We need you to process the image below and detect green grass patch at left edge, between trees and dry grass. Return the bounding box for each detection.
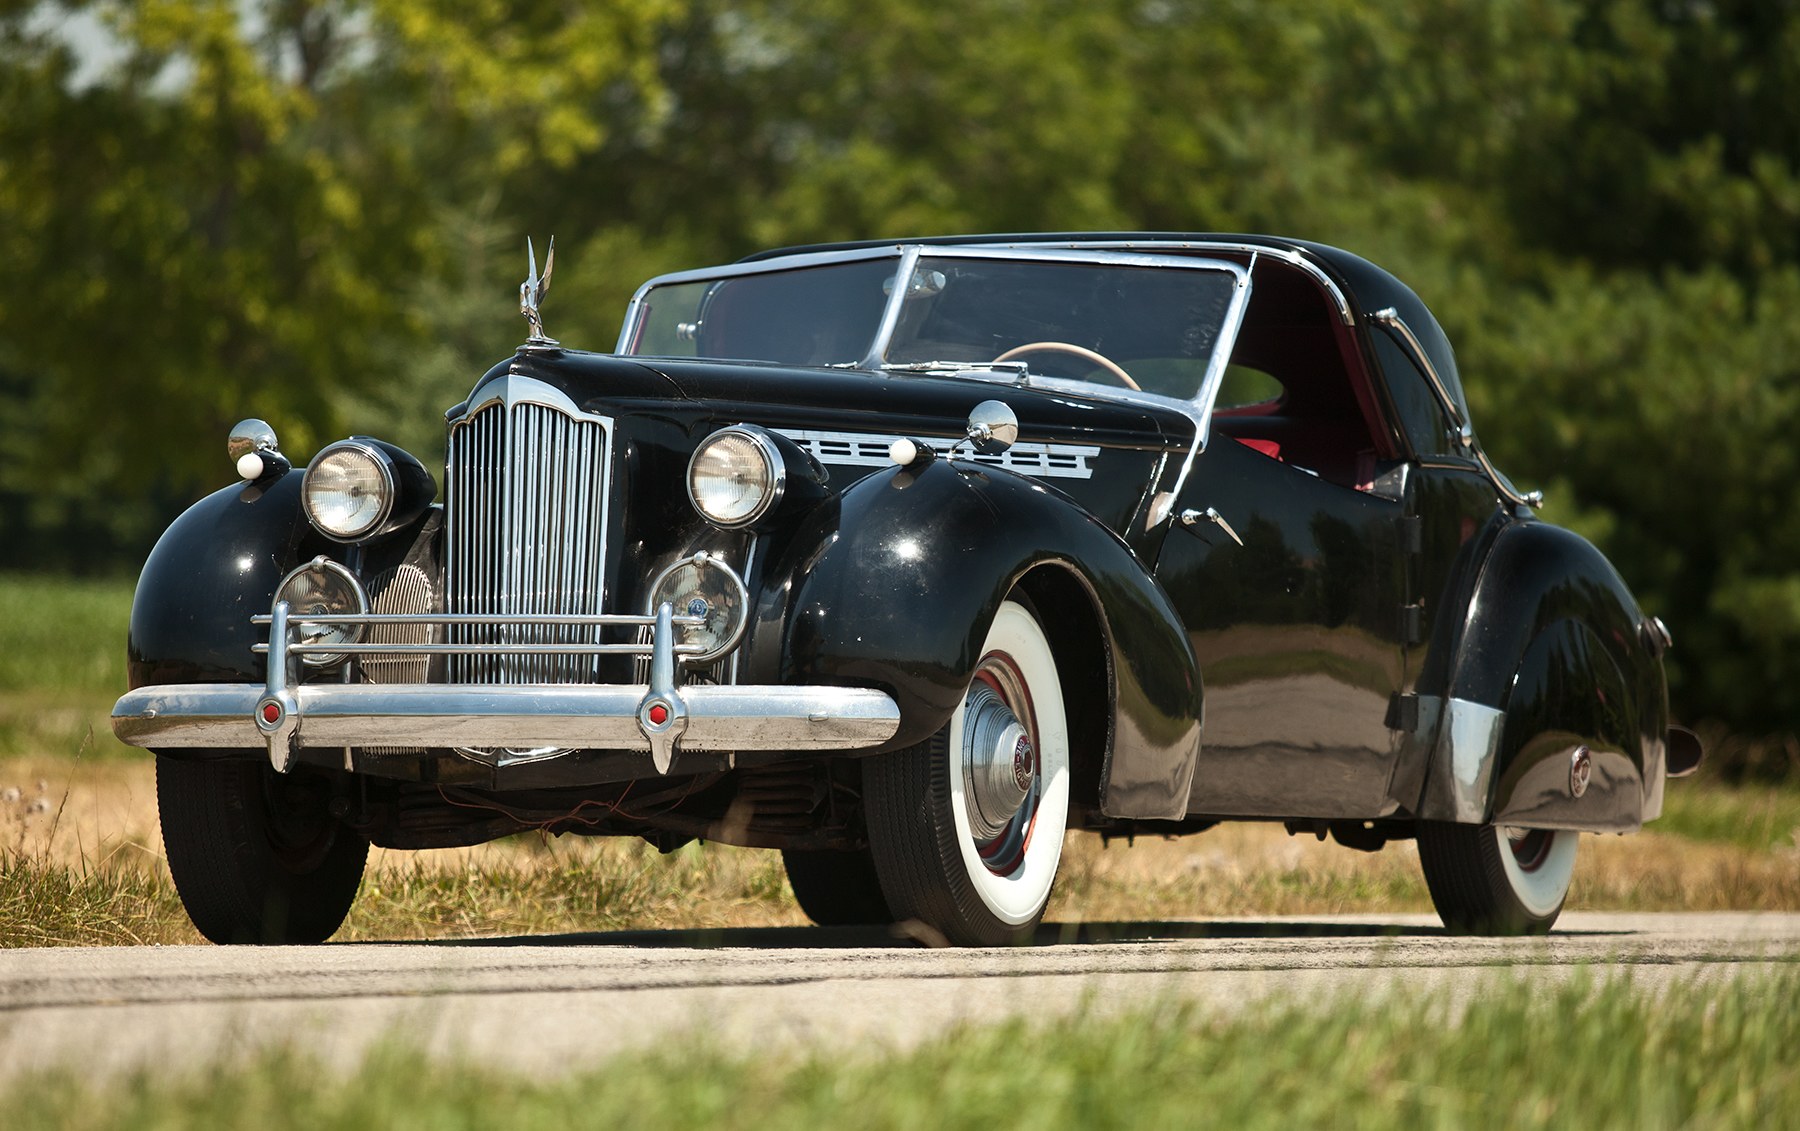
[0,575,133,758]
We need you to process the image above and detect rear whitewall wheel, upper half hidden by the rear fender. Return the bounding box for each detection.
[1418,821,1580,935]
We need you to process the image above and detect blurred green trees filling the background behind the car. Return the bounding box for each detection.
[0,0,1800,765]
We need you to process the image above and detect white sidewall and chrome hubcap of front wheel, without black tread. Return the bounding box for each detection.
[949,602,1069,924]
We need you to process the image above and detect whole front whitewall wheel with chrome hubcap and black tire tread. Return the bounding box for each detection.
[862,602,1069,946]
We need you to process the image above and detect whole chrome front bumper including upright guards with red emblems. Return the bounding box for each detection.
[113,603,900,773]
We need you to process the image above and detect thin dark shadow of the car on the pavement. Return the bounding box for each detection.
[412,920,1629,951]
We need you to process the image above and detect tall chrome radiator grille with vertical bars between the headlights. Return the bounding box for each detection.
[445,376,612,684]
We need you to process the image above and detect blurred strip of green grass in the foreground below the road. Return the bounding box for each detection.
[0,967,1800,1131]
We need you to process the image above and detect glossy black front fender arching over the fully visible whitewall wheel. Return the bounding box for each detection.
[749,459,1201,818]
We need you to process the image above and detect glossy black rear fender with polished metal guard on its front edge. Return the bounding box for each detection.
[1420,520,1669,832]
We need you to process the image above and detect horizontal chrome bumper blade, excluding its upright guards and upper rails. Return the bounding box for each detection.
[113,683,900,756]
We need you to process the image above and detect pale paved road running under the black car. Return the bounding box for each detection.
[0,913,1800,1073]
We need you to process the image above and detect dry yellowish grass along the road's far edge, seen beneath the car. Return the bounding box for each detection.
[0,758,1800,946]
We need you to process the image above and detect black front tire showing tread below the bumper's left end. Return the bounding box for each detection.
[157,758,369,944]
